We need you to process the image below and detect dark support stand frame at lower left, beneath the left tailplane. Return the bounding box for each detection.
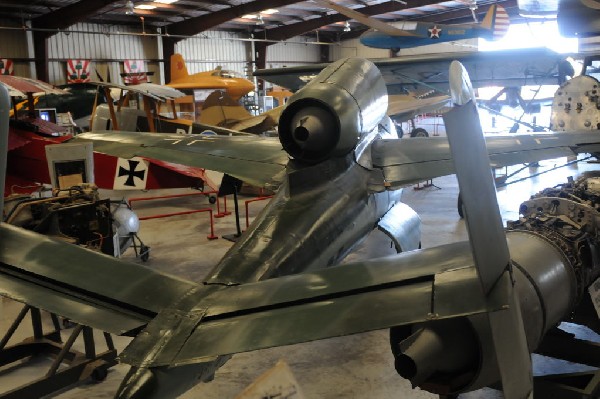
[0,305,117,399]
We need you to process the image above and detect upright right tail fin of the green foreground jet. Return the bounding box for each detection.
[444,61,533,399]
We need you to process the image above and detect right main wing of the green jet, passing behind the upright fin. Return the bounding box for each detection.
[372,131,600,188]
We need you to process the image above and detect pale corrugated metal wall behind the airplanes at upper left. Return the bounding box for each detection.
[0,21,320,84]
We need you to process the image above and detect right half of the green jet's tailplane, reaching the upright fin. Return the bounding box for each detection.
[122,242,505,367]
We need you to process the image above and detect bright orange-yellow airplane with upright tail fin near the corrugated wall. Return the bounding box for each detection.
[167,54,254,101]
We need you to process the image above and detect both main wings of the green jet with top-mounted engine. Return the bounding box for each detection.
[74,131,600,189]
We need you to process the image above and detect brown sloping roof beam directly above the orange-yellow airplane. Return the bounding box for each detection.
[167,0,308,36]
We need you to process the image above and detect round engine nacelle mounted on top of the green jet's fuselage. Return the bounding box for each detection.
[279,58,388,164]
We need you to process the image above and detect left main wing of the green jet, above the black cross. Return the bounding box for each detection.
[72,132,288,186]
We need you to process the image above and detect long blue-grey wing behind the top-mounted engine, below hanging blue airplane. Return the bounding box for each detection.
[254,48,572,94]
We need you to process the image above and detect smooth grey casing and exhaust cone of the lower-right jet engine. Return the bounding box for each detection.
[390,231,577,395]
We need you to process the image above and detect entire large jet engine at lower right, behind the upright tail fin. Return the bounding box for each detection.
[390,173,600,395]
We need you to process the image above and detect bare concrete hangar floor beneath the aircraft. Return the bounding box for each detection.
[0,158,593,399]
